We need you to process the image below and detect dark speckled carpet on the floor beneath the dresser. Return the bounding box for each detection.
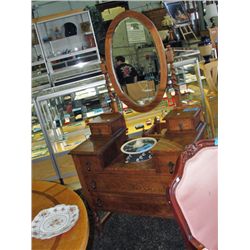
[76,190,185,250]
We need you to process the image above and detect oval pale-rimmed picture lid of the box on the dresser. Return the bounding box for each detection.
[121,137,157,155]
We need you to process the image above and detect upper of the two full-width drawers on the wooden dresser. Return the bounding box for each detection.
[85,174,172,195]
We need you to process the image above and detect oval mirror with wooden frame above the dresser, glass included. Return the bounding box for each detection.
[105,10,167,112]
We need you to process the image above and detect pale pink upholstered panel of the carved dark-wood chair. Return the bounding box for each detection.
[176,146,218,250]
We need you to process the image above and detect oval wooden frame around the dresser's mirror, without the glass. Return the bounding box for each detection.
[105,10,168,112]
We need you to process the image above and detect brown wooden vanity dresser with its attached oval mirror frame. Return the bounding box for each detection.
[70,11,206,227]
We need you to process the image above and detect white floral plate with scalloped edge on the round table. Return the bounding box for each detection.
[31,204,79,239]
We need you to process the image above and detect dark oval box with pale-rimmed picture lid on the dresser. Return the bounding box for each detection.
[121,137,157,163]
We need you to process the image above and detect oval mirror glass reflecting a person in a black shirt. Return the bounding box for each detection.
[112,18,160,105]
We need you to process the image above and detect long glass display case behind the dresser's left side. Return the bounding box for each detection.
[32,75,111,184]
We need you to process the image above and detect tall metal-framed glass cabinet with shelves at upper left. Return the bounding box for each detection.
[32,10,101,91]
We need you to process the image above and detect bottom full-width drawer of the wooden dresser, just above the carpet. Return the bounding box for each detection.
[93,193,174,218]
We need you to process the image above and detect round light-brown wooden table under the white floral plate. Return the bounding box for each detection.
[32,181,89,250]
